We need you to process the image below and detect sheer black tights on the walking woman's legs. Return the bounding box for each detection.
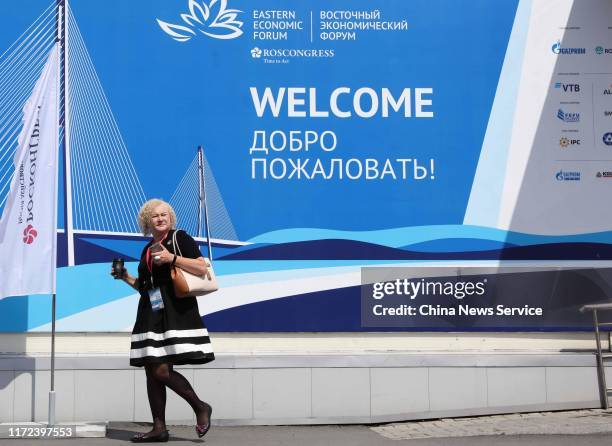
[145,364,209,431]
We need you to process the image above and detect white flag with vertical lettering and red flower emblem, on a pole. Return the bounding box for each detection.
[0,44,59,299]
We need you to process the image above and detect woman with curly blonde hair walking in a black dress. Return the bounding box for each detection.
[113,199,215,443]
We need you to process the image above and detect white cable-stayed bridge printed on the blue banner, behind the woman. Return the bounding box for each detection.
[0,2,246,266]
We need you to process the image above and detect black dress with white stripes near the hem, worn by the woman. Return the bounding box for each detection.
[130,230,215,367]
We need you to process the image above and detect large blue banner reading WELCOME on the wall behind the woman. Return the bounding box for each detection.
[0,0,612,331]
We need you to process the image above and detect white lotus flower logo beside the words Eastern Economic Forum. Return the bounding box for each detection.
[156,0,243,42]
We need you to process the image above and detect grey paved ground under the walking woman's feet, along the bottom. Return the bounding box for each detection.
[0,410,612,446]
